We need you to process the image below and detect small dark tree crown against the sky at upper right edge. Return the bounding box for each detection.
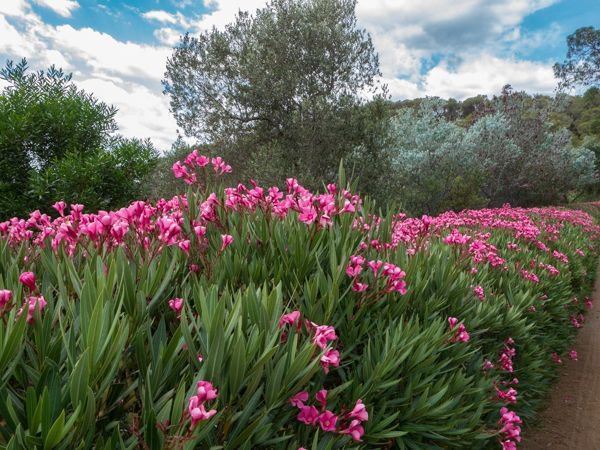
[554,27,600,89]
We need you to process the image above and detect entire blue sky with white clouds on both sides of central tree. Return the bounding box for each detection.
[0,0,600,149]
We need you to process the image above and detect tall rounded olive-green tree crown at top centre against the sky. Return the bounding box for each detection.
[164,0,379,186]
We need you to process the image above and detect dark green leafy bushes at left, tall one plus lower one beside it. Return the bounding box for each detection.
[0,60,157,218]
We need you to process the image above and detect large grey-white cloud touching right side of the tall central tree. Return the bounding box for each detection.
[357,0,558,89]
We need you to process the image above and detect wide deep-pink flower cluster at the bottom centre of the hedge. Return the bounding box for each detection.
[289,389,369,442]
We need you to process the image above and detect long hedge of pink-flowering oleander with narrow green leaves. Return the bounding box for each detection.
[0,152,599,449]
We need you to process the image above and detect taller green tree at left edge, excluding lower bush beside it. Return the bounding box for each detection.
[0,59,117,217]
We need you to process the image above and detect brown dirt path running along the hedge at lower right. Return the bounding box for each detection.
[519,267,600,450]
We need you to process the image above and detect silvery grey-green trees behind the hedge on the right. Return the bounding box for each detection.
[389,90,598,214]
